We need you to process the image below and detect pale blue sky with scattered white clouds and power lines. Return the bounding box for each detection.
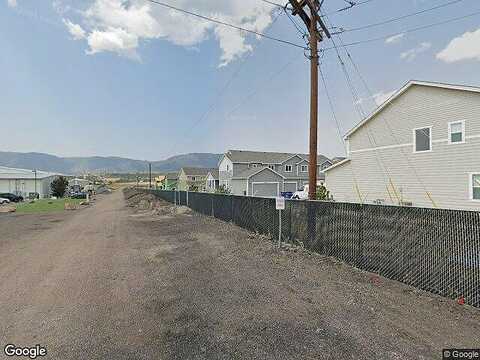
[0,0,480,160]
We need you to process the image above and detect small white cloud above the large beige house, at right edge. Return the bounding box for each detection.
[437,29,480,63]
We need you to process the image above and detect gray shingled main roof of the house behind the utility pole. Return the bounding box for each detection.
[225,150,329,164]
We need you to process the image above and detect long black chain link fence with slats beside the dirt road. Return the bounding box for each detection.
[145,190,480,307]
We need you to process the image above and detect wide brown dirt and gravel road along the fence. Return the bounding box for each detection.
[0,192,480,360]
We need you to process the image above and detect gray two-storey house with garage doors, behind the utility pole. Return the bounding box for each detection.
[219,150,333,197]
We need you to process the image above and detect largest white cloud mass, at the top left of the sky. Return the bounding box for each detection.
[55,0,274,66]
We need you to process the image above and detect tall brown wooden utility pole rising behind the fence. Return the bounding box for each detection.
[289,0,330,200]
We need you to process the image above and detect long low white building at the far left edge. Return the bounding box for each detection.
[0,166,59,198]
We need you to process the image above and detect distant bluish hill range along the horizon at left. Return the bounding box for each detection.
[0,151,221,174]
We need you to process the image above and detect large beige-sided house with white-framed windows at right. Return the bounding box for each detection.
[326,81,480,210]
